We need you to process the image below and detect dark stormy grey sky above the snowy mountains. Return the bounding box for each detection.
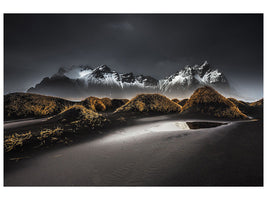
[4,14,263,99]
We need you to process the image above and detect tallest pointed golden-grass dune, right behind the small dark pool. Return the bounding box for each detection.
[182,86,248,119]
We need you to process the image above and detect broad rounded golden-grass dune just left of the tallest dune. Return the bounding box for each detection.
[115,94,182,113]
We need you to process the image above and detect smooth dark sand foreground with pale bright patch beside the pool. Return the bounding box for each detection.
[4,116,263,186]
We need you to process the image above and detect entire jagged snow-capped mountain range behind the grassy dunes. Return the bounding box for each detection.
[28,62,230,98]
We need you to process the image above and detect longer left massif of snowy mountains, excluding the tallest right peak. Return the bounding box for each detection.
[27,65,158,98]
